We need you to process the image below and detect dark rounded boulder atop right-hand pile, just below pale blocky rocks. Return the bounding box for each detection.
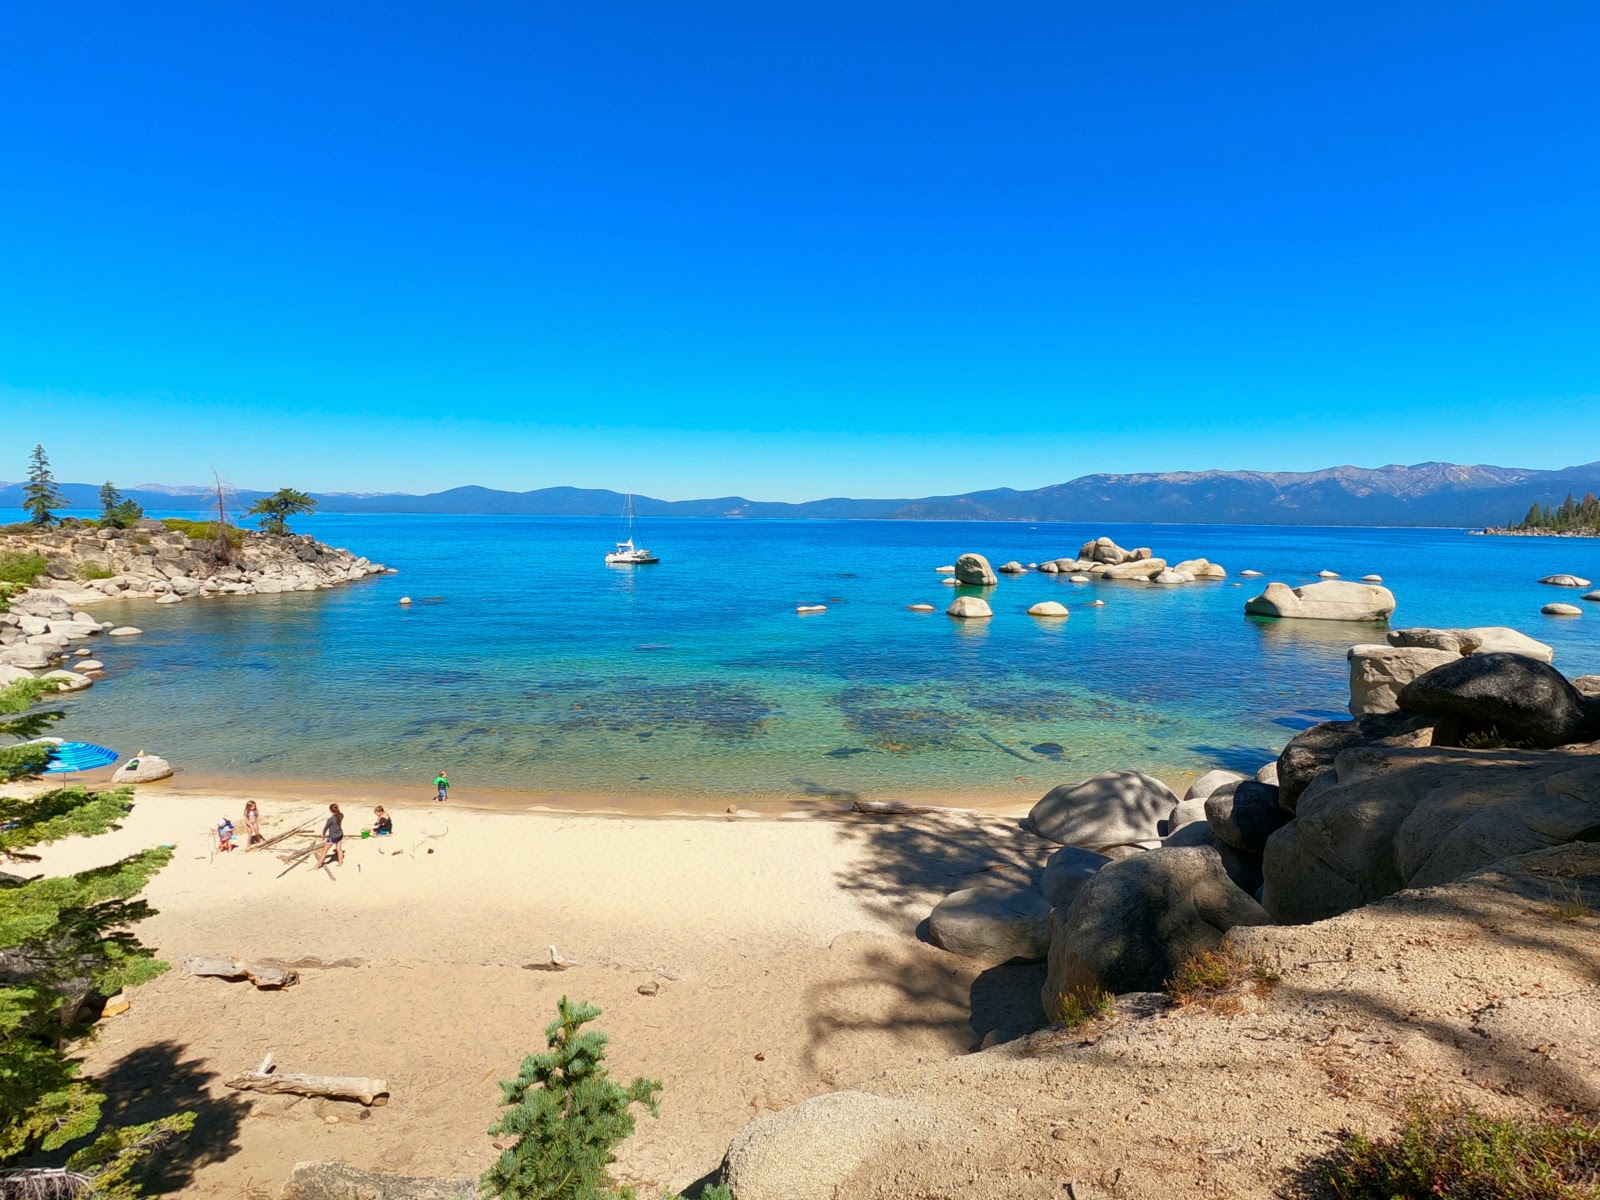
[1398,654,1587,747]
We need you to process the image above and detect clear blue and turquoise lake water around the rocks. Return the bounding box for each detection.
[21,515,1600,800]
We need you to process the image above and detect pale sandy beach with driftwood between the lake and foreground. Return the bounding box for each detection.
[42,786,1038,1197]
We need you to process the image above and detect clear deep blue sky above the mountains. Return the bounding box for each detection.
[0,0,1600,499]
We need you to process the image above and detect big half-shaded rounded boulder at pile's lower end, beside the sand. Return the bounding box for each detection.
[1043,846,1269,1013]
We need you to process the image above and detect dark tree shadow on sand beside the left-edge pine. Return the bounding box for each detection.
[94,1042,250,1195]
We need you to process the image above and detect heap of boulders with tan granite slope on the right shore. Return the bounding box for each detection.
[722,643,1600,1200]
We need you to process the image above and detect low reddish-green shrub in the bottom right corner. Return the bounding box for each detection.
[1304,1099,1600,1200]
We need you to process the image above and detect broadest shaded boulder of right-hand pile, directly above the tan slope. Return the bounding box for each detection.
[1262,746,1600,923]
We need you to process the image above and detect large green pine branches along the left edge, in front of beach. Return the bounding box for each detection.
[0,680,194,1200]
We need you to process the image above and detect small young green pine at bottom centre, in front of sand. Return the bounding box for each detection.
[483,995,661,1200]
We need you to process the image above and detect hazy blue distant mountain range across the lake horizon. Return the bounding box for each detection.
[0,462,1600,526]
